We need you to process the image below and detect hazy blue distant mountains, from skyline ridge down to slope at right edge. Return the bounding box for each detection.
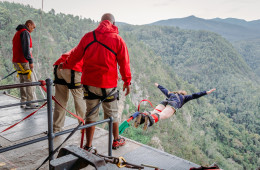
[151,16,260,77]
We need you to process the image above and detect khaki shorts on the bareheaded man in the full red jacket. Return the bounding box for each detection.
[83,86,118,122]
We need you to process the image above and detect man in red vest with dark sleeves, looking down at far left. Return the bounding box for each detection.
[12,20,39,109]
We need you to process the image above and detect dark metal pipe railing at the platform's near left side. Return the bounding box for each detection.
[0,79,113,169]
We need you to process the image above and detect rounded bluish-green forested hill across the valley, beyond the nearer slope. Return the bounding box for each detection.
[120,26,260,131]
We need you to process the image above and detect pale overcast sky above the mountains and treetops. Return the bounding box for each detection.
[0,0,260,25]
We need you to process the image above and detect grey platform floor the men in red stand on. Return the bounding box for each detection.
[0,94,199,170]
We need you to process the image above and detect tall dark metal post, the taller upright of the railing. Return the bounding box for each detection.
[46,79,54,168]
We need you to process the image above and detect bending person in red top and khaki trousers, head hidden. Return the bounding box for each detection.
[53,49,86,133]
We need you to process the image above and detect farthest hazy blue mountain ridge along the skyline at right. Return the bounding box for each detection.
[149,16,260,41]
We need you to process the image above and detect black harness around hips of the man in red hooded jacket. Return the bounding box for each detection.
[83,85,119,102]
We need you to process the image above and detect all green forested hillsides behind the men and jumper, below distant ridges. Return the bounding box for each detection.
[0,2,260,169]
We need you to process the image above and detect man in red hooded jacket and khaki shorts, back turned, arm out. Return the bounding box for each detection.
[63,13,131,150]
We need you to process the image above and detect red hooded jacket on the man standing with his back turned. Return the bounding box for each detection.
[64,20,131,88]
